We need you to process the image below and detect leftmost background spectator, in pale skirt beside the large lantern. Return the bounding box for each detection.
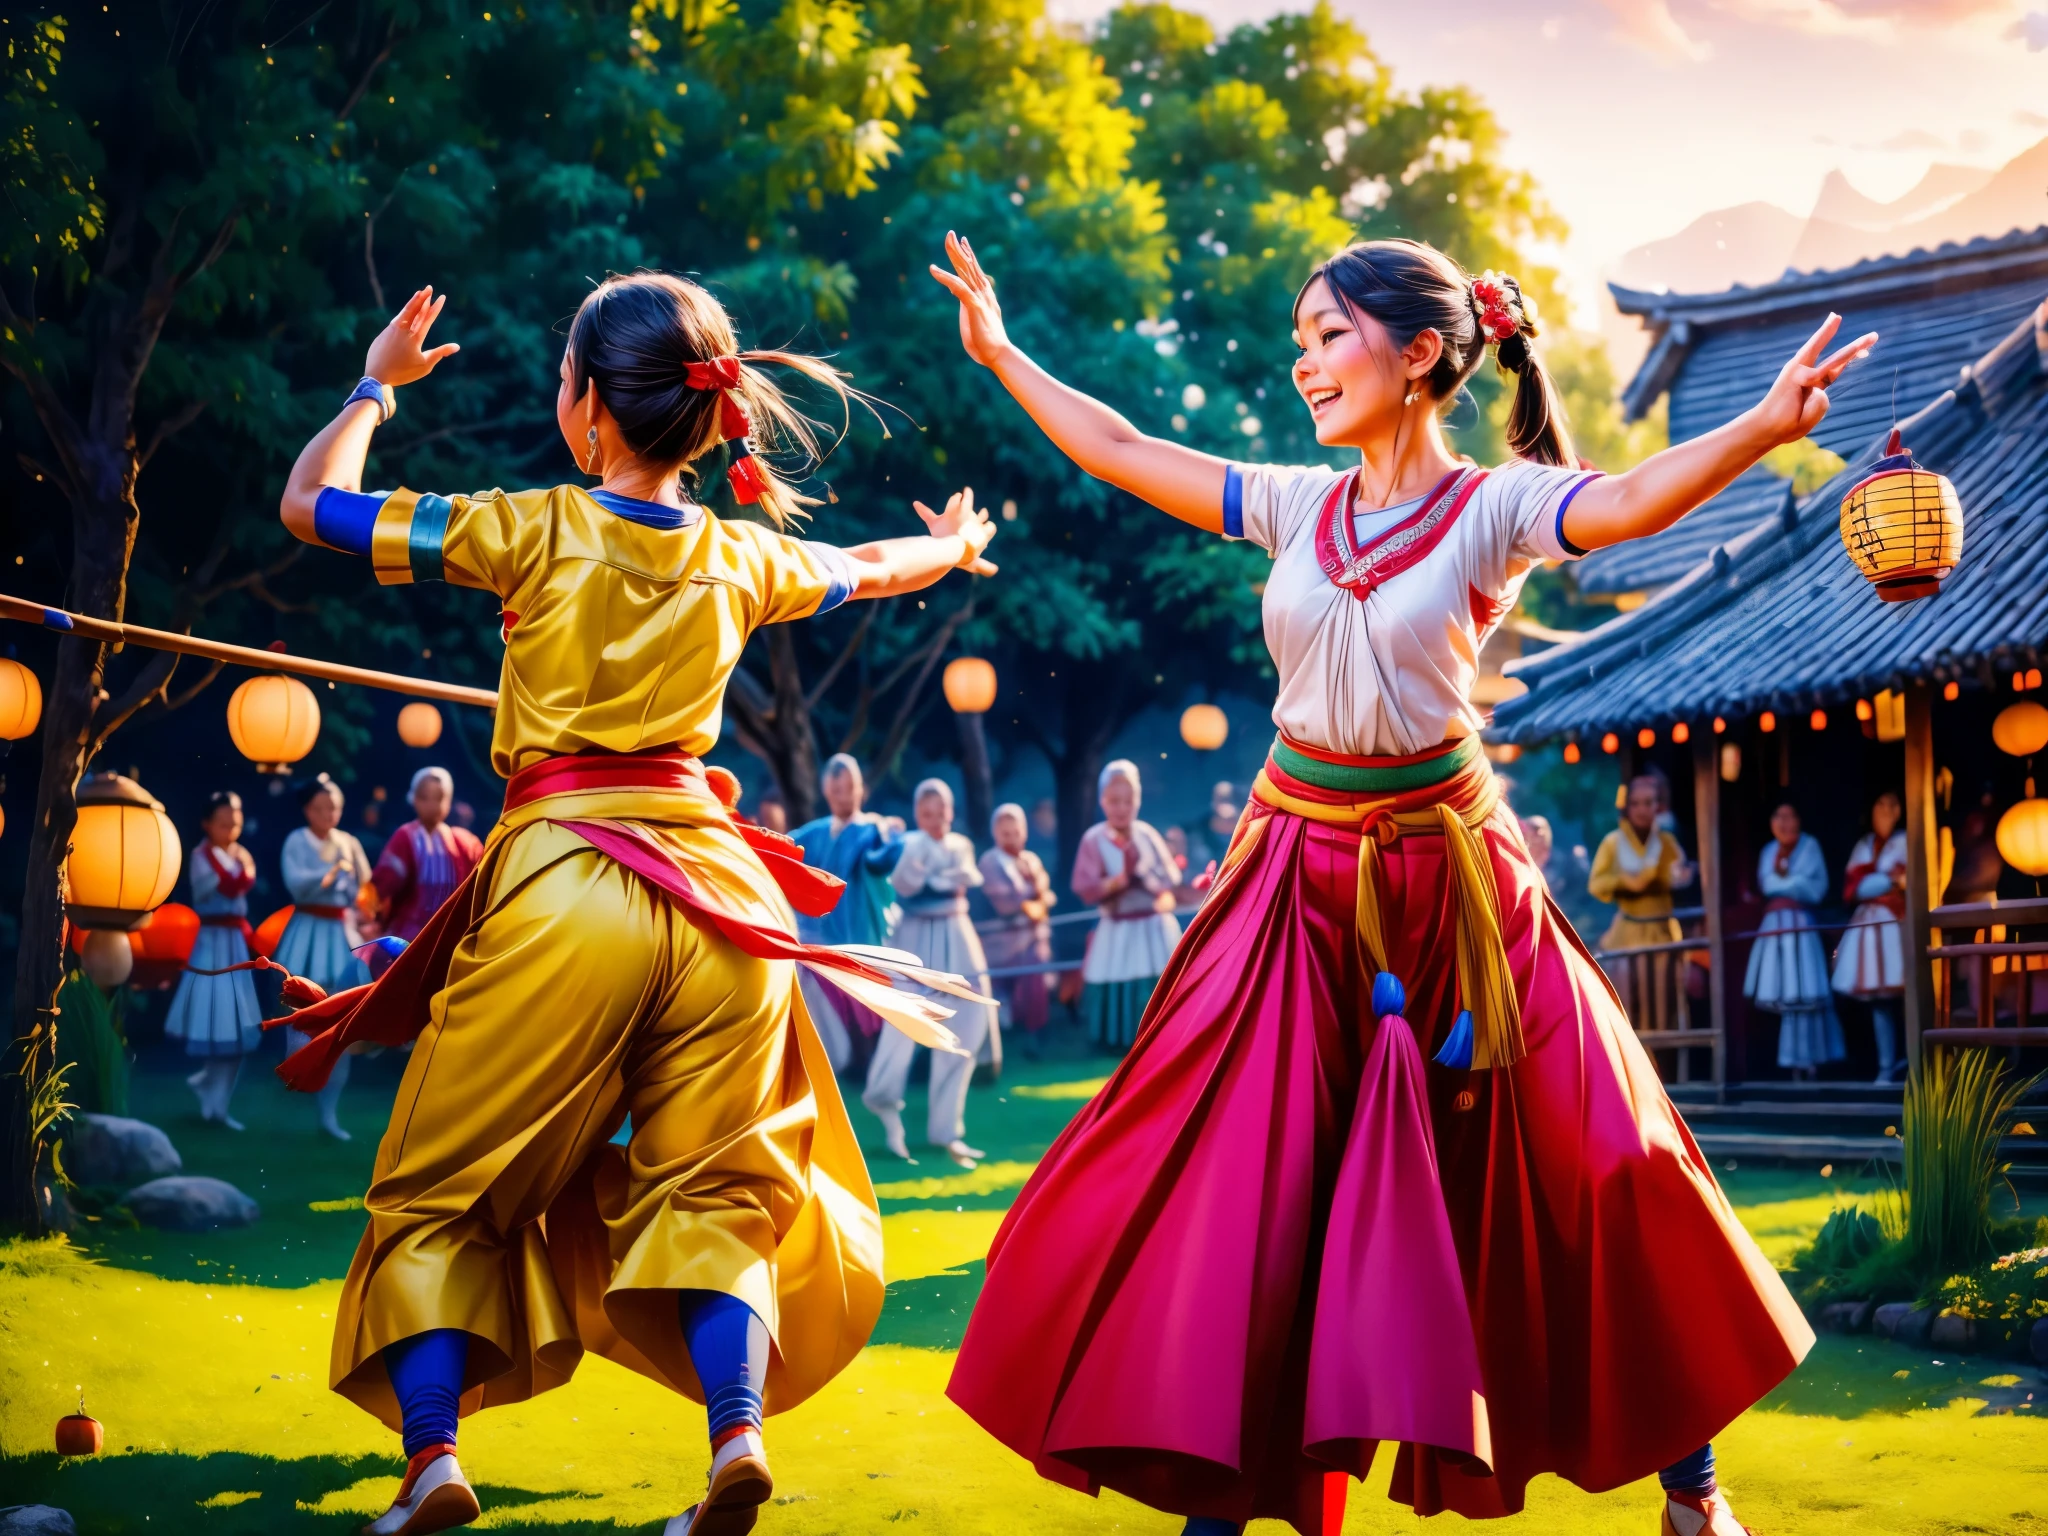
[164,791,262,1130]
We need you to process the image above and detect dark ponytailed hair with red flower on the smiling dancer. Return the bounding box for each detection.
[1294,240,1579,465]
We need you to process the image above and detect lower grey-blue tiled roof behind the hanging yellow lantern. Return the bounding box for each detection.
[1489,305,2048,743]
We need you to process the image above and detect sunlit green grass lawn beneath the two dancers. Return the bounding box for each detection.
[0,1040,2048,1536]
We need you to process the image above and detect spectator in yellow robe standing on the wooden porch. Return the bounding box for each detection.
[1585,774,1694,1030]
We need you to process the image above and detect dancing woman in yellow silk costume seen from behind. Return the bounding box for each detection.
[281,274,993,1536]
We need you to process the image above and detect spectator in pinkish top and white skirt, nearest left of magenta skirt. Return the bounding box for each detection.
[1073,758,1180,1055]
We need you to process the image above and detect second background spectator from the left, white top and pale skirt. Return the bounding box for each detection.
[270,774,371,1141]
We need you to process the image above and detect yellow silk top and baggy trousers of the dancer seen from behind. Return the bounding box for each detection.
[330,487,883,1427]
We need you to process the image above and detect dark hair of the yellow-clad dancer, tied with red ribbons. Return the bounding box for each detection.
[569,272,850,524]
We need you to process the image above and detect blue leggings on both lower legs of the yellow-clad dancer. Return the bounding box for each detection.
[383,1290,768,1456]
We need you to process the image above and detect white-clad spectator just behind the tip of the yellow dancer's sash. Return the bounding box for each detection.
[860,778,1001,1167]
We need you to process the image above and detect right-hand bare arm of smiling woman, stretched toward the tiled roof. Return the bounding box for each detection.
[1565,315,1878,549]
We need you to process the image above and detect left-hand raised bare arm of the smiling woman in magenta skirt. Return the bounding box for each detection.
[932,229,1227,532]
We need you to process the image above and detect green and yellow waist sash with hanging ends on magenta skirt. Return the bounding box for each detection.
[1219,737,1526,1069]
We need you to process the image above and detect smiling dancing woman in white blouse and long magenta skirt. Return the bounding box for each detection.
[932,236,1876,1536]
